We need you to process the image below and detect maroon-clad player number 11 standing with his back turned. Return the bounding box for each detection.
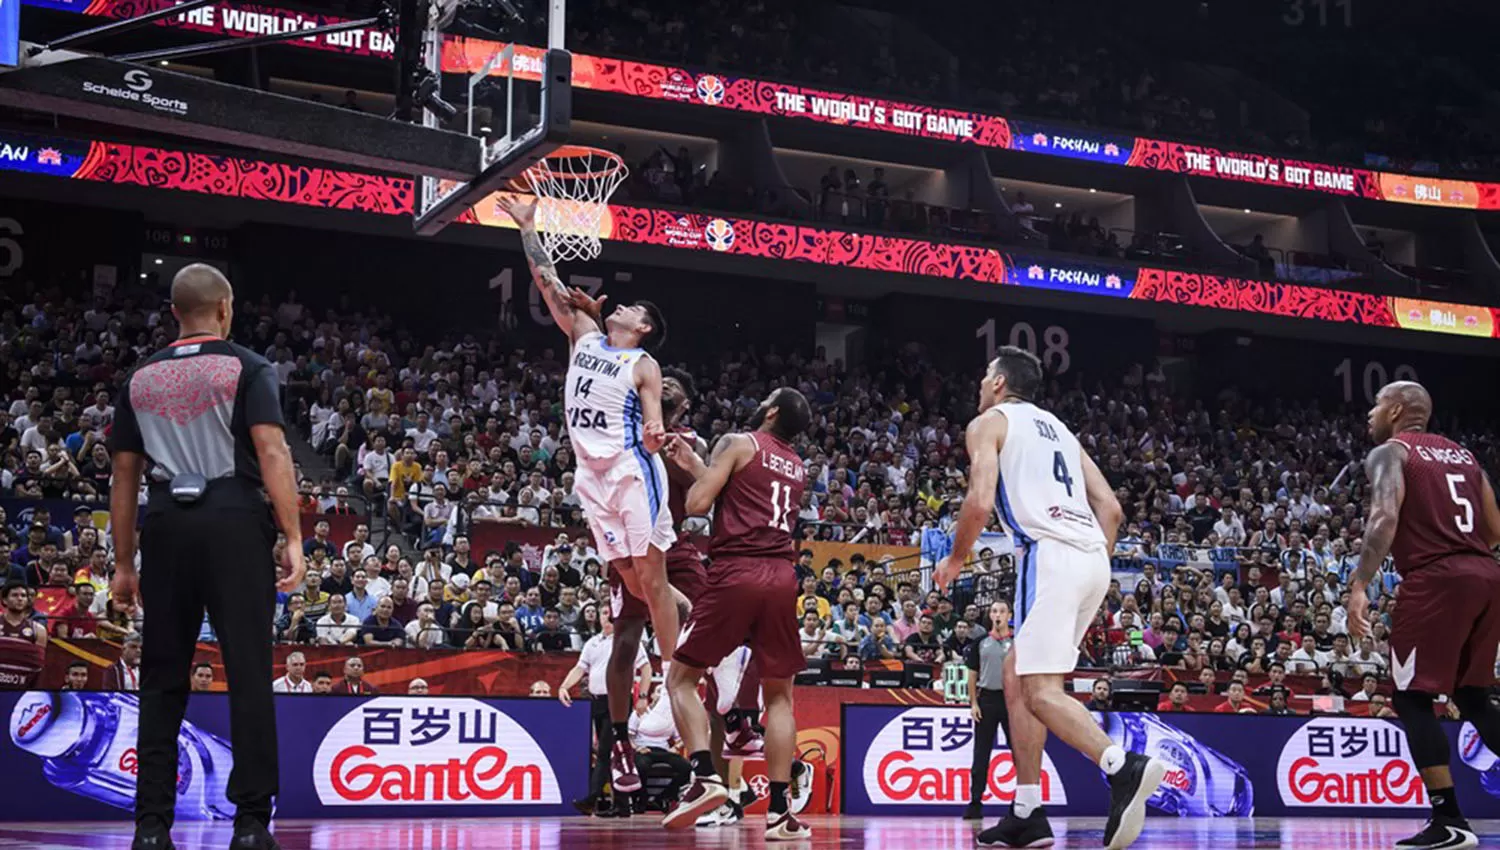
[662,387,812,841]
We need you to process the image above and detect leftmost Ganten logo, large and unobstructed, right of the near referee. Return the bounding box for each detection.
[312,697,561,807]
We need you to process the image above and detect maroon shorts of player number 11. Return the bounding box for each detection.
[674,555,807,679]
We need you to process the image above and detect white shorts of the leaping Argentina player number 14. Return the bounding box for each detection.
[573,450,677,561]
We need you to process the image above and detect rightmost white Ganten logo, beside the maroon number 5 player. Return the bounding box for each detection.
[1277,718,1427,808]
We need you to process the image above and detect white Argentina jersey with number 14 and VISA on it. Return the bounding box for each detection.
[563,331,650,466]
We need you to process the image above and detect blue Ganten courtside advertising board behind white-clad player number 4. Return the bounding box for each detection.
[840,705,1500,819]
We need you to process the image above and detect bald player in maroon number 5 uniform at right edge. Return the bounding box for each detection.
[1349,381,1500,850]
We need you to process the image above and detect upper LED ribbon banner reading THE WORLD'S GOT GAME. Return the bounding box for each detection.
[24,0,1500,210]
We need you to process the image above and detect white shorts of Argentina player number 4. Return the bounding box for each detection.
[1011,540,1110,676]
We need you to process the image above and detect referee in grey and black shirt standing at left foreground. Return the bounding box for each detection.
[110,264,305,850]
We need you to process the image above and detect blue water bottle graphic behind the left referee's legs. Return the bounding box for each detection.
[11,691,236,820]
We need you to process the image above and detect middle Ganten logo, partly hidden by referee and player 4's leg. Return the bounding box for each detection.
[861,706,1068,805]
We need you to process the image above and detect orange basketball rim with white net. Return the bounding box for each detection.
[525,145,630,262]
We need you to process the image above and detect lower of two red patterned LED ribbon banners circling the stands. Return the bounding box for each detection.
[0,133,1500,337]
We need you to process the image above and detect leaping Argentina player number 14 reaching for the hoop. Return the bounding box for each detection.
[498,196,680,677]
